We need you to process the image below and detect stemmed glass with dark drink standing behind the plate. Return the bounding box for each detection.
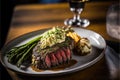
[64,0,90,27]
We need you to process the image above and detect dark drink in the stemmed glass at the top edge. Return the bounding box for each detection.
[69,0,85,8]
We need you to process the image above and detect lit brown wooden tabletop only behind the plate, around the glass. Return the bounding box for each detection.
[6,2,118,43]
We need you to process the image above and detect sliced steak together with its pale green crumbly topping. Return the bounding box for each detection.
[32,29,74,69]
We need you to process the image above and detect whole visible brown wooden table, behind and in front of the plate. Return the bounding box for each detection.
[6,2,118,80]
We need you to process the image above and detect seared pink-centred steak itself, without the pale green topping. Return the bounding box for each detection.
[32,38,74,69]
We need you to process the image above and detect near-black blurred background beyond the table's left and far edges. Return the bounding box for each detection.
[0,0,119,80]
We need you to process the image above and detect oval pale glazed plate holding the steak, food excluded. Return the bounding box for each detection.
[1,28,106,76]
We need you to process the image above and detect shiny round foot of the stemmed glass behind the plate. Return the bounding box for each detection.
[64,18,90,28]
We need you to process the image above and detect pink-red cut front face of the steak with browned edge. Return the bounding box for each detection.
[33,47,72,69]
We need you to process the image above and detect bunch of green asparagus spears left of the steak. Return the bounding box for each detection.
[7,36,42,67]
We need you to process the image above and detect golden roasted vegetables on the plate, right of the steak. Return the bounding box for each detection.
[67,32,91,55]
